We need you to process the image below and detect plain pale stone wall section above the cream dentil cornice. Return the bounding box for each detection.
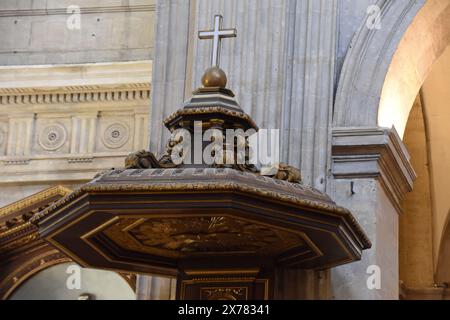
[0,0,155,65]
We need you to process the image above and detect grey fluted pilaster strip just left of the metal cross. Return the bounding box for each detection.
[150,0,193,153]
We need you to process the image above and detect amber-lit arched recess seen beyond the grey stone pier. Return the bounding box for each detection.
[400,47,450,296]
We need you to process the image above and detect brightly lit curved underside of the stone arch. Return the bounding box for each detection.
[378,0,450,136]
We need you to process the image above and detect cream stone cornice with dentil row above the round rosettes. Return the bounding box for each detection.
[0,60,152,106]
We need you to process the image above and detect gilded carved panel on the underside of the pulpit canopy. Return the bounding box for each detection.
[103,217,304,257]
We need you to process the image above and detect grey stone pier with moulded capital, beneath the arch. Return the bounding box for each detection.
[329,128,415,300]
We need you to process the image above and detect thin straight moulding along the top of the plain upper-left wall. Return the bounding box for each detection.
[0,5,156,17]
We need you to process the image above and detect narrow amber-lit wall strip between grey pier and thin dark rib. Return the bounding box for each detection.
[400,96,434,289]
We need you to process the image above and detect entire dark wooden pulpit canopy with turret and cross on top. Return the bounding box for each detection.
[32,16,371,300]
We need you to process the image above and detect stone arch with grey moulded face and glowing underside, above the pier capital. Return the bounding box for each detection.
[334,0,450,136]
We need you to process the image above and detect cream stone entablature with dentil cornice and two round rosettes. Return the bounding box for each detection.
[0,61,152,206]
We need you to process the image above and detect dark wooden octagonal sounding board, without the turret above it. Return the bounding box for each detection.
[32,168,370,275]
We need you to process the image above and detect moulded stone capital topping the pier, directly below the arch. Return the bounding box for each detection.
[332,128,416,213]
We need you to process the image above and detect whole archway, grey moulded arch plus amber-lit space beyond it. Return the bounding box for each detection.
[333,0,450,298]
